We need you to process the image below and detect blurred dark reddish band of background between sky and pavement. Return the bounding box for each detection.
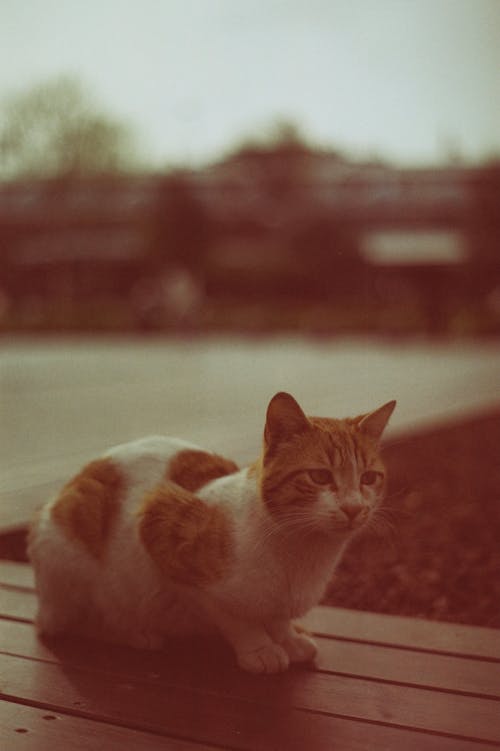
[0,156,500,334]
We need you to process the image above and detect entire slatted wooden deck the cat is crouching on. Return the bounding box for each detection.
[0,561,500,751]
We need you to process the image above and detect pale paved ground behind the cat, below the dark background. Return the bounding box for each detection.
[0,338,500,528]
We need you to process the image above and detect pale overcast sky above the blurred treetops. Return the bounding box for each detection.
[0,0,500,165]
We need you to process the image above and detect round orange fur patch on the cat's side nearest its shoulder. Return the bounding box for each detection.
[139,481,232,587]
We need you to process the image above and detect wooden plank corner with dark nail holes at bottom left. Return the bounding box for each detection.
[0,701,221,751]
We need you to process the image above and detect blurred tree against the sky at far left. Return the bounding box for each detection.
[0,76,135,178]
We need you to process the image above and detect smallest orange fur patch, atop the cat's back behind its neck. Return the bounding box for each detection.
[168,449,238,492]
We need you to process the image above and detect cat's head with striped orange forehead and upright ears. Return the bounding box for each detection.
[261,392,396,537]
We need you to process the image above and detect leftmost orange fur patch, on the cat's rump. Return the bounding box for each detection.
[51,459,124,558]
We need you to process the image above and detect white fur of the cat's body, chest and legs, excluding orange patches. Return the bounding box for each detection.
[30,436,356,672]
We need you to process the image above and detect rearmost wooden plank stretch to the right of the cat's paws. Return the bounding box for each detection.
[302,606,500,660]
